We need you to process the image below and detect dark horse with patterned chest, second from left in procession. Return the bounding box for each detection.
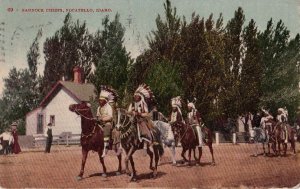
[116,109,163,181]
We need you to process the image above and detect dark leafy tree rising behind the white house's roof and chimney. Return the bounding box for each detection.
[42,13,93,95]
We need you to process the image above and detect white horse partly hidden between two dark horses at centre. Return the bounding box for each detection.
[153,121,176,165]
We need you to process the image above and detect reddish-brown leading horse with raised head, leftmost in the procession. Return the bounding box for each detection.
[69,102,122,180]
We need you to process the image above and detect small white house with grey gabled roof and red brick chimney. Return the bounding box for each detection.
[26,67,95,135]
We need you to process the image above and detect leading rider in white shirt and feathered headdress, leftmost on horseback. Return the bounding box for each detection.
[97,86,118,157]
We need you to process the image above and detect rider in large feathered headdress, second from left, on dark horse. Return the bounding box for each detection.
[128,84,154,142]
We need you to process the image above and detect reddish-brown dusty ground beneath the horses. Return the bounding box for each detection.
[0,144,300,188]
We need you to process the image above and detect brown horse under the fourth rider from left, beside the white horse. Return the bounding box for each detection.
[172,123,215,165]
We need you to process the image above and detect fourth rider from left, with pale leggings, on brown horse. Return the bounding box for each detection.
[188,99,203,147]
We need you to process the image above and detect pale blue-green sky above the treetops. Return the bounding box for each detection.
[0,0,300,94]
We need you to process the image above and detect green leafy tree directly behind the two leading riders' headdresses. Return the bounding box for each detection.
[91,14,132,104]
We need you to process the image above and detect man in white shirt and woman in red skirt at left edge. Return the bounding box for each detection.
[0,122,21,155]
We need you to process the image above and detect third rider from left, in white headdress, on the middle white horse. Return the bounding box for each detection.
[170,96,183,125]
